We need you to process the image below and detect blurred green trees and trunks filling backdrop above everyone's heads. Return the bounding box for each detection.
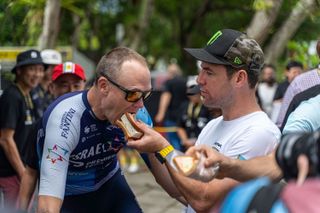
[0,0,320,83]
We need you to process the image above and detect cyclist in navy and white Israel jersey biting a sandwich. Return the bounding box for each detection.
[37,47,152,212]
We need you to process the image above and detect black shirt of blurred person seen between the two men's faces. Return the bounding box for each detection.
[164,77,188,122]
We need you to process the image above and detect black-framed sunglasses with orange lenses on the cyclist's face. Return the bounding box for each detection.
[100,73,152,102]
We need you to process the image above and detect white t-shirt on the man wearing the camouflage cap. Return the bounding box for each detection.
[187,111,281,213]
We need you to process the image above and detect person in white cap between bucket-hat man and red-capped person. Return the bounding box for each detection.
[31,49,62,120]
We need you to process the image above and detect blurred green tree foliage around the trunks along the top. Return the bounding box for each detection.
[0,0,320,74]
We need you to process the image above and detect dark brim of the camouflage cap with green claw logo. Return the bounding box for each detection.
[184,48,230,65]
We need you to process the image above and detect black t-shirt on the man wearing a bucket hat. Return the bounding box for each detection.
[0,85,35,177]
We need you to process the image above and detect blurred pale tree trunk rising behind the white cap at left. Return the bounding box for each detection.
[38,0,61,50]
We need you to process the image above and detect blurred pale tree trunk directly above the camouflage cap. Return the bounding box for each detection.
[246,0,282,45]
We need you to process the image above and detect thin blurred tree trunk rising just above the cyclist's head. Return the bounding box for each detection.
[130,0,154,50]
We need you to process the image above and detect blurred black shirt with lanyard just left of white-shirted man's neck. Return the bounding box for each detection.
[177,102,212,138]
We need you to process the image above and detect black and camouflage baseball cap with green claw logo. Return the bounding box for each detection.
[185,29,264,72]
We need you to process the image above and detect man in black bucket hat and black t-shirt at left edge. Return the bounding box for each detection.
[0,49,44,208]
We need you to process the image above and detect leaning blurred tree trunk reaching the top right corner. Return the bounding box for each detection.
[265,0,318,64]
